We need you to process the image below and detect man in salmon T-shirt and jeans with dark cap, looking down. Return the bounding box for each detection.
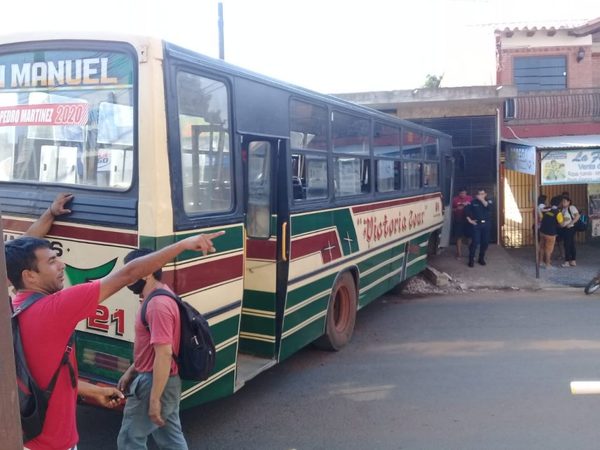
[117,249,188,450]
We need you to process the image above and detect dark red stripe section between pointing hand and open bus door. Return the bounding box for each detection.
[175,255,244,295]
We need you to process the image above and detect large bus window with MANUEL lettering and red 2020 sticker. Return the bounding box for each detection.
[0,50,134,190]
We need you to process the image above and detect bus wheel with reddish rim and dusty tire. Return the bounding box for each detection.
[315,272,357,351]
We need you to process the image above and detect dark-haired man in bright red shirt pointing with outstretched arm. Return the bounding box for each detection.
[5,212,222,450]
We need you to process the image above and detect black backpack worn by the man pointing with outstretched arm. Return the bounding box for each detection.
[10,293,77,442]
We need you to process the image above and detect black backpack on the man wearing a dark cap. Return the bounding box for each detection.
[141,289,216,381]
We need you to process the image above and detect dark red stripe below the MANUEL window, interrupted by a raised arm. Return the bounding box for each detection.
[2,219,138,247]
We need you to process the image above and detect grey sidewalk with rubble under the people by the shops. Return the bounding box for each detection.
[429,244,600,290]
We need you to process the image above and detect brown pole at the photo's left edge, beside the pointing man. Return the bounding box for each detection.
[0,214,23,450]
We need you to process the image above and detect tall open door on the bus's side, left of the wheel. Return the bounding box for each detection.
[236,136,289,388]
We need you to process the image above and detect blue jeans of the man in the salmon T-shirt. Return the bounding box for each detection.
[117,373,188,450]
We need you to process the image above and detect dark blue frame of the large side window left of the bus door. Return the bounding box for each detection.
[164,58,244,231]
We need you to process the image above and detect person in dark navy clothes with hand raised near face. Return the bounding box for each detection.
[466,188,492,267]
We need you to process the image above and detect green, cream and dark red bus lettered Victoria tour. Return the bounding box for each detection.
[0,33,452,408]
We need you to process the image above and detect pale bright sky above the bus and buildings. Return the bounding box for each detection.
[2,0,600,93]
